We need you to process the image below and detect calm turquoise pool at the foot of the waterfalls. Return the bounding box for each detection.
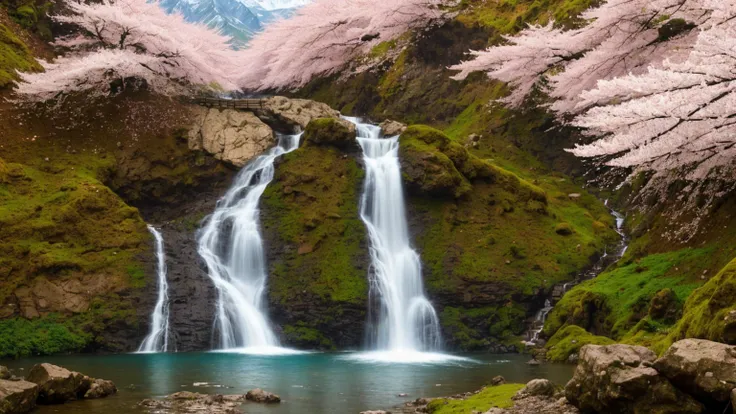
[0,353,573,414]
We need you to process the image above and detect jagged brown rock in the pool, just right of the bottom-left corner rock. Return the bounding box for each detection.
[26,363,117,404]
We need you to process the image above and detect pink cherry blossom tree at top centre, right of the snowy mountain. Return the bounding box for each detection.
[240,0,445,90]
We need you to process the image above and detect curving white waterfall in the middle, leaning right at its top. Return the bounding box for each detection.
[198,135,301,354]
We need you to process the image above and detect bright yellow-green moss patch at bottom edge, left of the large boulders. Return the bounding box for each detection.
[427,384,524,414]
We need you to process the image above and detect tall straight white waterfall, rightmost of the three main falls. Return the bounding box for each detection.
[348,118,441,353]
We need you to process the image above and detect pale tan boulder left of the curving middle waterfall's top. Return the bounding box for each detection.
[189,107,276,167]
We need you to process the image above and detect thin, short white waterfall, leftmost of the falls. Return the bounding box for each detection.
[138,225,169,352]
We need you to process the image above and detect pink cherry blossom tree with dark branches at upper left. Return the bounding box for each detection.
[16,0,241,101]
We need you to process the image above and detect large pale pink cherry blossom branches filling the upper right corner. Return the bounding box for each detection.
[452,0,736,180]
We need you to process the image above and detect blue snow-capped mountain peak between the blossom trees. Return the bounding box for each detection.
[160,0,311,44]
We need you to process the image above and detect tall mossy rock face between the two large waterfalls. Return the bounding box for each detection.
[261,145,369,349]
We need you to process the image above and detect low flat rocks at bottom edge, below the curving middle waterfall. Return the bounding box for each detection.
[138,391,245,414]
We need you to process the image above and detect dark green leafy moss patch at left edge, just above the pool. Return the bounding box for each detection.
[0,314,90,358]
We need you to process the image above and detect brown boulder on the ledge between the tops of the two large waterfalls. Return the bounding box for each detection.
[256,96,340,133]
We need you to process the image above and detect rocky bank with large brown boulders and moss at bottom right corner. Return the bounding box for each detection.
[376,339,736,414]
